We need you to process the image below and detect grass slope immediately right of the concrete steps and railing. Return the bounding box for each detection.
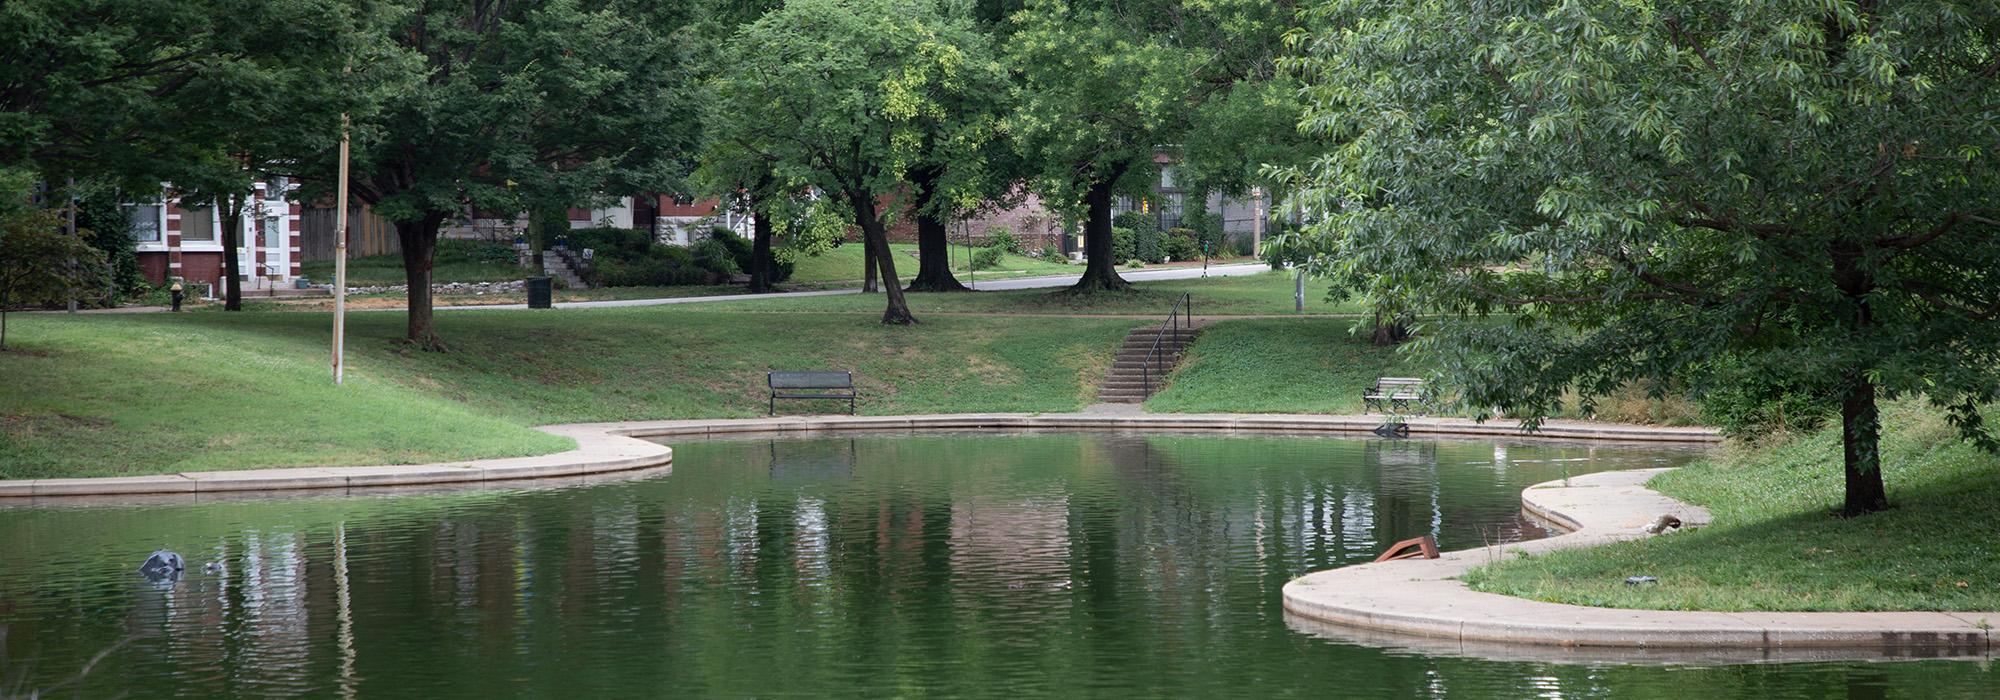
[1146,318,1422,414]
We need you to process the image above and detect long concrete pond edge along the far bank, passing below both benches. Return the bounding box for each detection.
[0,414,1720,504]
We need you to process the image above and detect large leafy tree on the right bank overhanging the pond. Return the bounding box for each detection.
[1298,0,2000,514]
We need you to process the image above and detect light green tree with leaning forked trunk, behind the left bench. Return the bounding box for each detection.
[708,0,996,324]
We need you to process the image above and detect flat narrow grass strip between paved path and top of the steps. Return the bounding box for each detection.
[702,268,1362,320]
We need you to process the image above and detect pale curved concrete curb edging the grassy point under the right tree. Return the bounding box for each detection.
[1284,470,2000,658]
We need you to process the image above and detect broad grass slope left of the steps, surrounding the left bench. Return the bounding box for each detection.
[0,308,1134,478]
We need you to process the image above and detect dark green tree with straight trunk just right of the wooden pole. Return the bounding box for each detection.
[354,0,700,350]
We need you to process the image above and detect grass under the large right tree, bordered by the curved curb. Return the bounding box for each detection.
[1466,404,2000,612]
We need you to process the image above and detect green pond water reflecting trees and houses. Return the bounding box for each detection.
[0,434,2000,700]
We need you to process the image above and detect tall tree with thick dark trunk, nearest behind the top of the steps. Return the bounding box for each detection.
[1002,0,1292,292]
